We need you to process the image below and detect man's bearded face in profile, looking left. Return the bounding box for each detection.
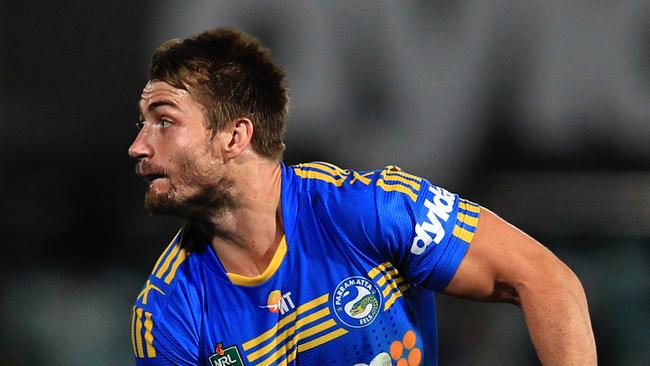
[129,81,234,218]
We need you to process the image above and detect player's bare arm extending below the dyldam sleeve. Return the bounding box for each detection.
[444,208,596,365]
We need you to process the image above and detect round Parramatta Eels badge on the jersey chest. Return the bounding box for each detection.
[332,276,382,328]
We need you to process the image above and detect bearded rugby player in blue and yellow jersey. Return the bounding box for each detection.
[129,28,596,366]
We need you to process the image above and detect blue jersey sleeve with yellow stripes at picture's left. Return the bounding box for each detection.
[131,229,200,365]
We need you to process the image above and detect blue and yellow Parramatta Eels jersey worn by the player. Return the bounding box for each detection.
[131,162,480,366]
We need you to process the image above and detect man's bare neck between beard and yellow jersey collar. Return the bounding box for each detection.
[200,159,284,277]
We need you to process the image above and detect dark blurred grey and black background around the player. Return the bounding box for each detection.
[0,0,650,365]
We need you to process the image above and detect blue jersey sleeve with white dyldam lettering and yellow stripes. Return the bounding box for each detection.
[373,166,480,291]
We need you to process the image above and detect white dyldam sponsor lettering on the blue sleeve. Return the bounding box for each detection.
[411,186,456,255]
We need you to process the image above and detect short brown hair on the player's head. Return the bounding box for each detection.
[149,28,289,159]
